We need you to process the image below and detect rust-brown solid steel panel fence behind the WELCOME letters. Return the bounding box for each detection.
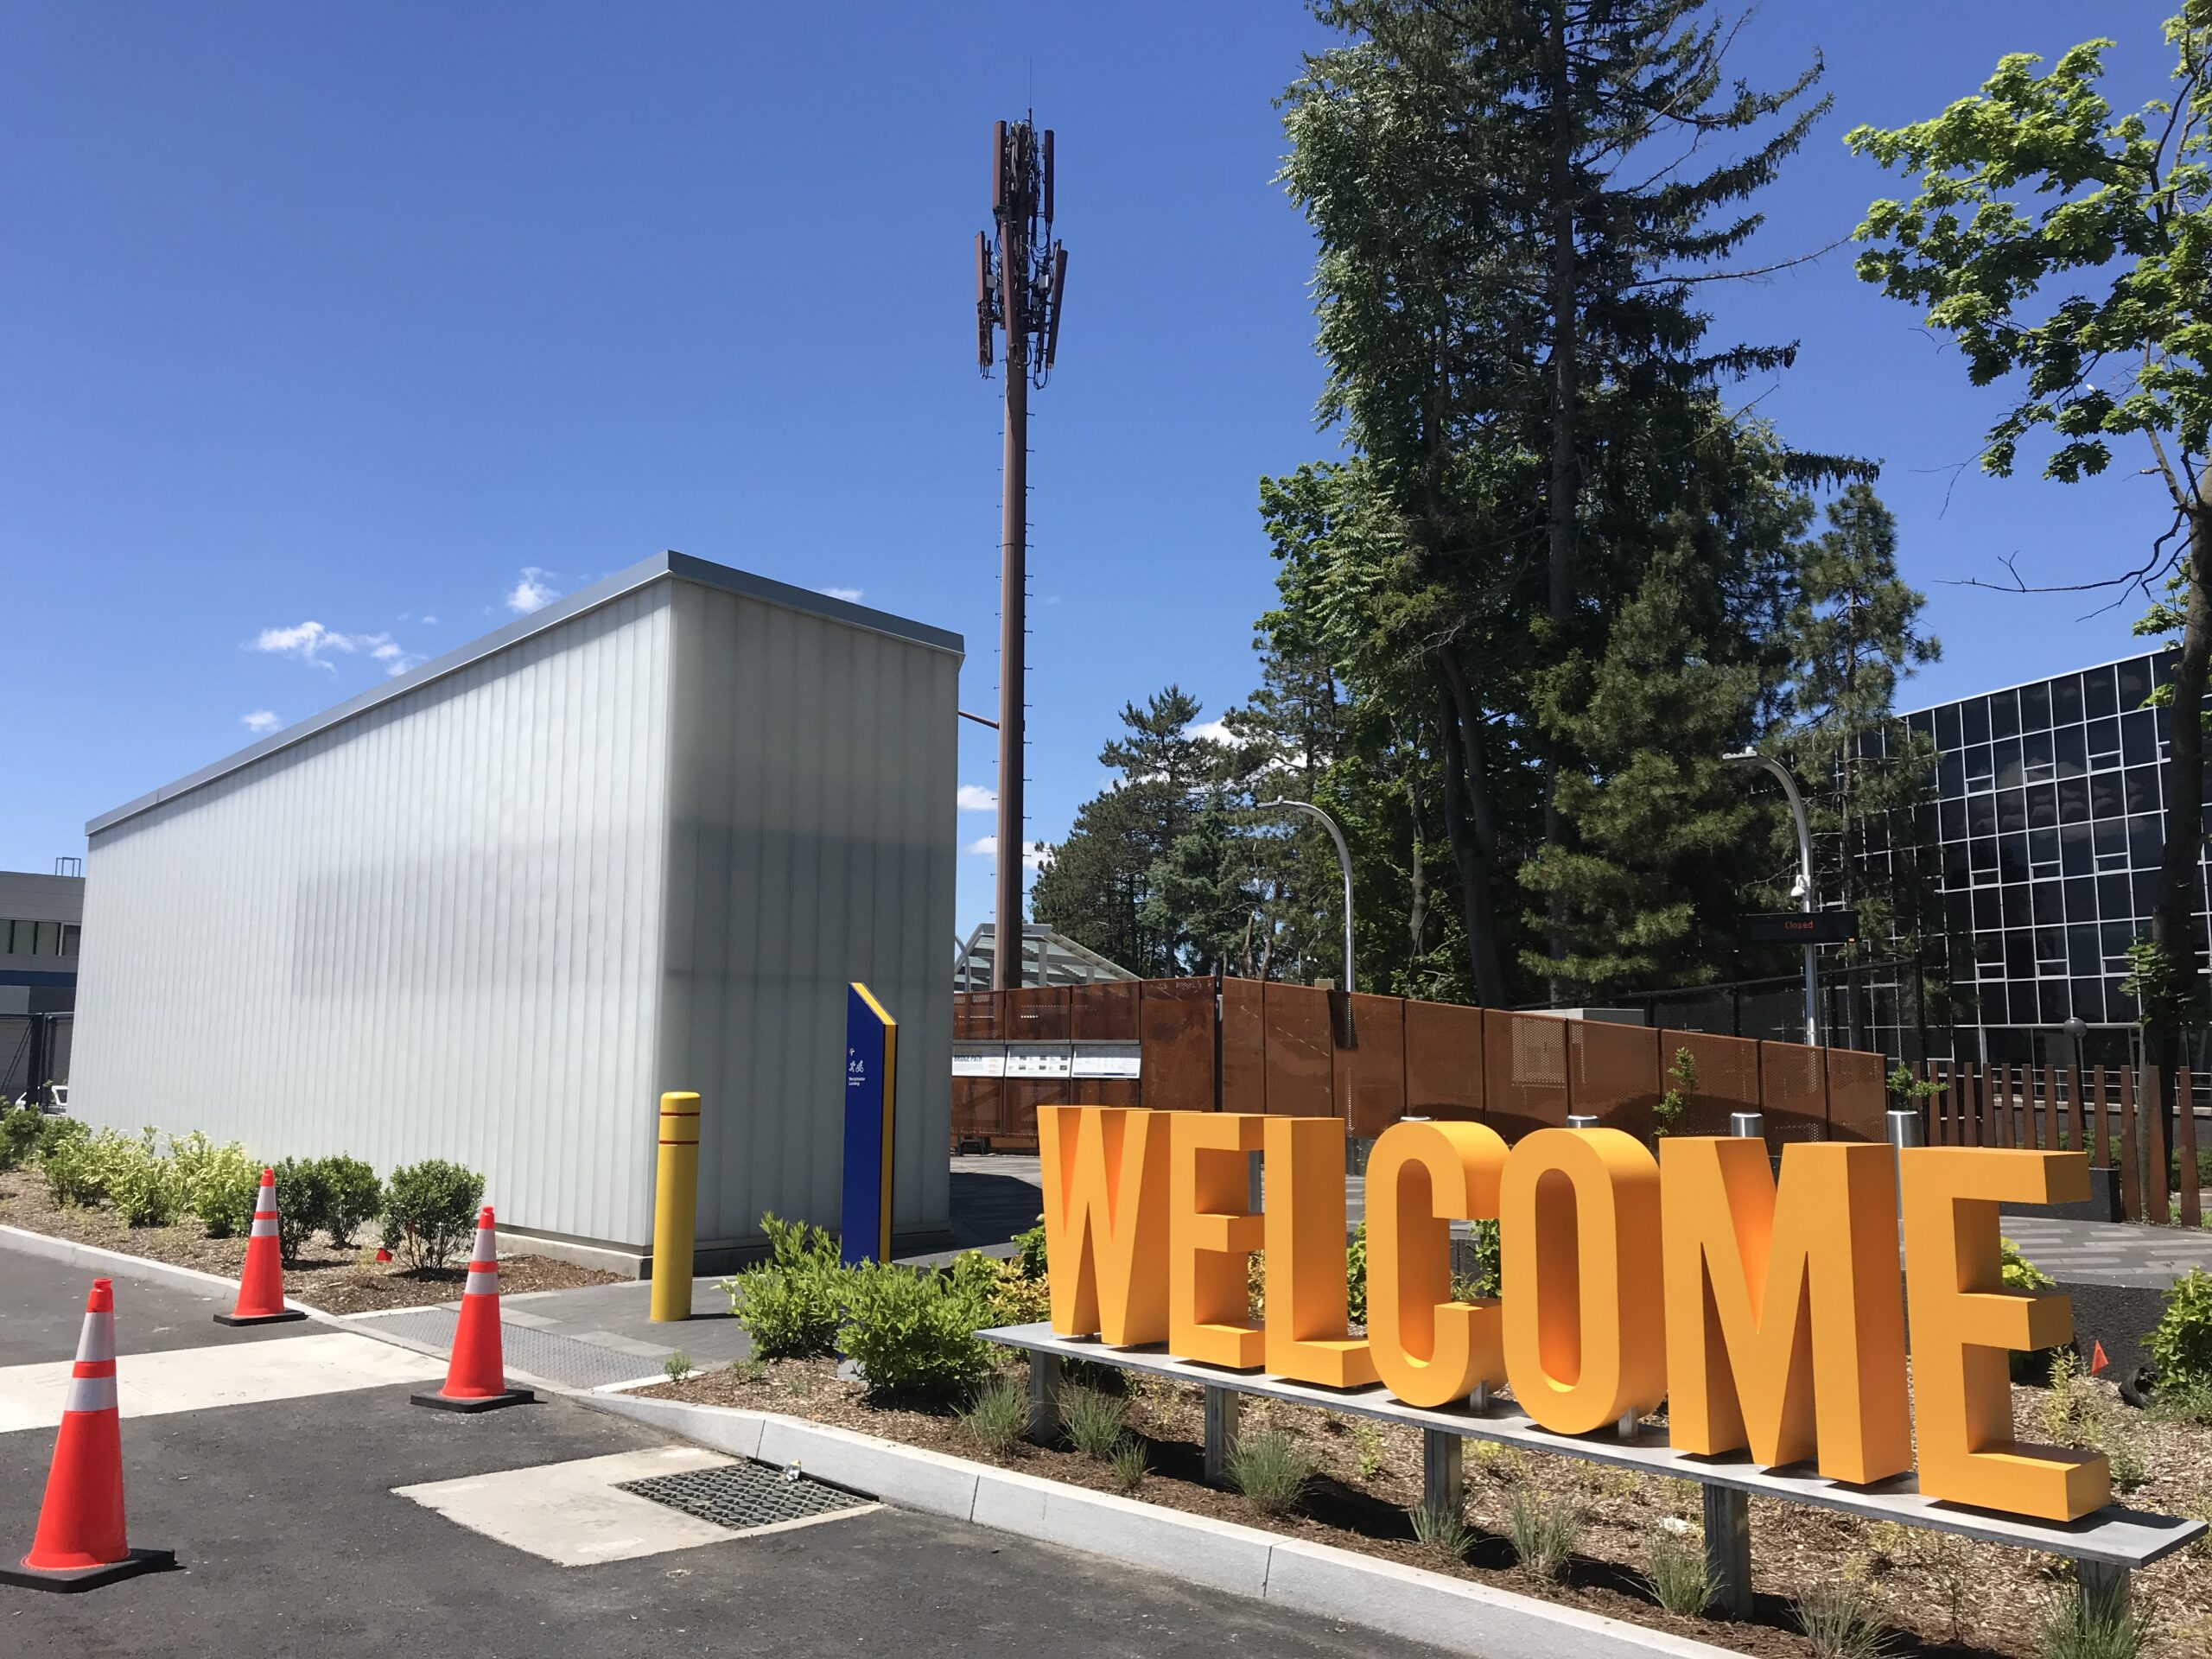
[951,978,1887,1150]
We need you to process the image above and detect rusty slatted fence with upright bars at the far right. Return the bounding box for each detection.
[1923,1062,2203,1228]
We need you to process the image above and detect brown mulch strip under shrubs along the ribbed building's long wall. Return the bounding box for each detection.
[0,1170,617,1314]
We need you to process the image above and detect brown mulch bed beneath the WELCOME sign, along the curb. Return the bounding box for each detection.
[639,1360,2212,1659]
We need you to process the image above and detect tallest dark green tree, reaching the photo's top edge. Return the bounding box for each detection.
[1263,0,1834,1002]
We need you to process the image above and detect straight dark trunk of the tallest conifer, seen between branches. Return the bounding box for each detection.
[1544,0,1577,1002]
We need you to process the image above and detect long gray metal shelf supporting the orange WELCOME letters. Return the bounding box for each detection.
[978,1323,2208,1592]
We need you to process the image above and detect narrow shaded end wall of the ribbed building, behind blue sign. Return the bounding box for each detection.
[659,584,960,1241]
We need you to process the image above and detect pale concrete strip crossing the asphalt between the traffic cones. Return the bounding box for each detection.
[0,1332,445,1433]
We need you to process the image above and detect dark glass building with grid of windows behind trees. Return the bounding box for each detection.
[1869,652,2205,1062]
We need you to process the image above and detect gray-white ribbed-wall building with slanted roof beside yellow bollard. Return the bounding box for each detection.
[71,553,963,1269]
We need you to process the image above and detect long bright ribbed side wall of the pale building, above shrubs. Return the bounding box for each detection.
[71,582,672,1243]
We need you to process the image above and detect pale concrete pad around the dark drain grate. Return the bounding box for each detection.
[391,1446,736,1566]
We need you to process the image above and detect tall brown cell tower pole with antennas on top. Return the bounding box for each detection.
[976,119,1068,991]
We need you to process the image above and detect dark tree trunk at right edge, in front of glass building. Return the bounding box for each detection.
[2144,506,2212,1167]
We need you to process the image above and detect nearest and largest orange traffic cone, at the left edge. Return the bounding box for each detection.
[0,1279,177,1591]
